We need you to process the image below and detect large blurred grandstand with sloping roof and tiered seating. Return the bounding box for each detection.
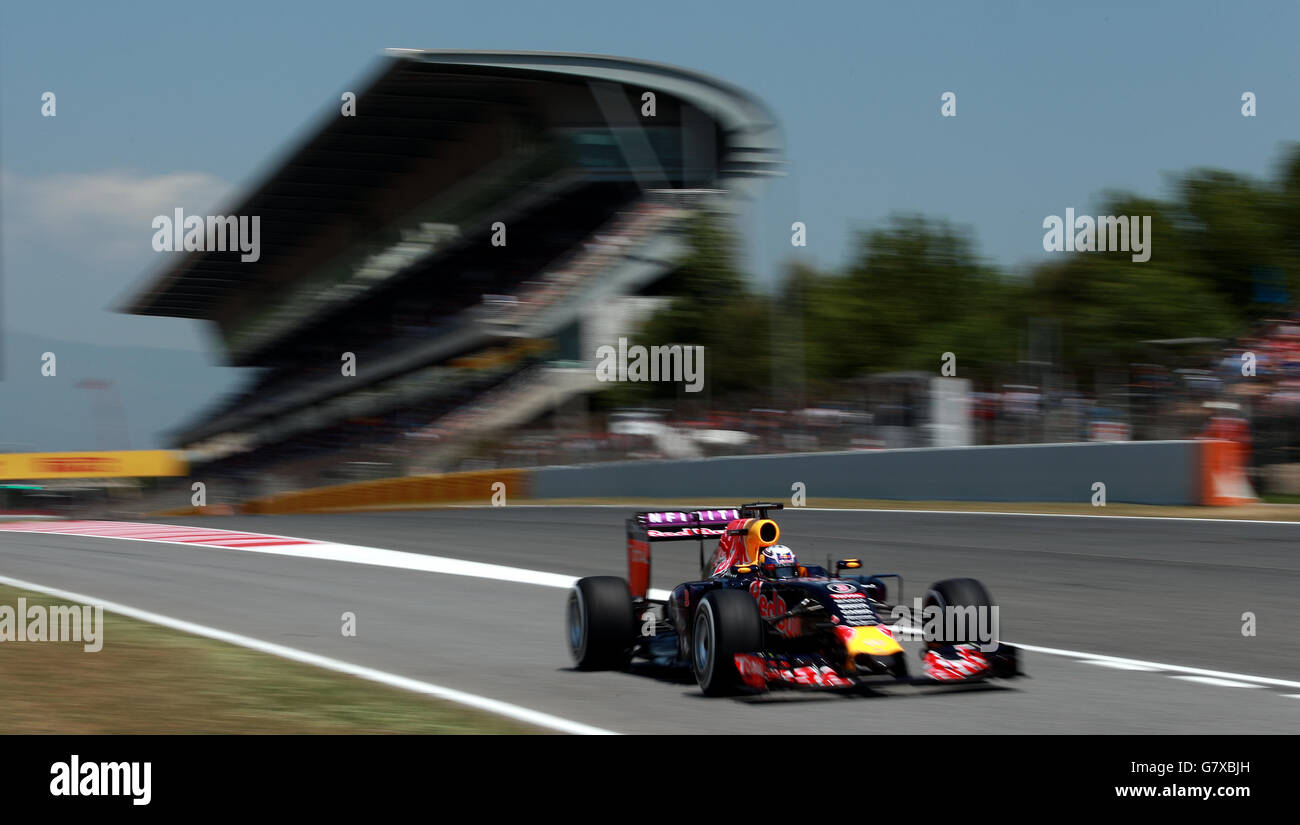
[125,49,783,492]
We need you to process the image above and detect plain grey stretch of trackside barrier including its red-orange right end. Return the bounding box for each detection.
[530,440,1216,504]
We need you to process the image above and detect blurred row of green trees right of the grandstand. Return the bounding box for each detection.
[605,144,1300,405]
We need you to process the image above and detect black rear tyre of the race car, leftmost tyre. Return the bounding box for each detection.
[566,576,637,670]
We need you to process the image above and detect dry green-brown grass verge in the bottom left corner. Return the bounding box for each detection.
[0,585,543,734]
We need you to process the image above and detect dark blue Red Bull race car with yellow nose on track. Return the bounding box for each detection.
[567,501,1021,696]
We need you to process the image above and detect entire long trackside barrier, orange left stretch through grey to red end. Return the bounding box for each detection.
[194,440,1256,513]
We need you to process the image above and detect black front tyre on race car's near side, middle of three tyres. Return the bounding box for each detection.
[690,590,763,696]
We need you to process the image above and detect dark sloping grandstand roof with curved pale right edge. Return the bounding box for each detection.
[125,49,783,324]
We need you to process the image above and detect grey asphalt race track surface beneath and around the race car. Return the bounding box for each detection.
[0,507,1300,734]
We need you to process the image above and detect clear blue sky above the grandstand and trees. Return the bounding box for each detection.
[0,0,1300,444]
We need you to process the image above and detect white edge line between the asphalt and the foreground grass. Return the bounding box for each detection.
[0,576,614,734]
